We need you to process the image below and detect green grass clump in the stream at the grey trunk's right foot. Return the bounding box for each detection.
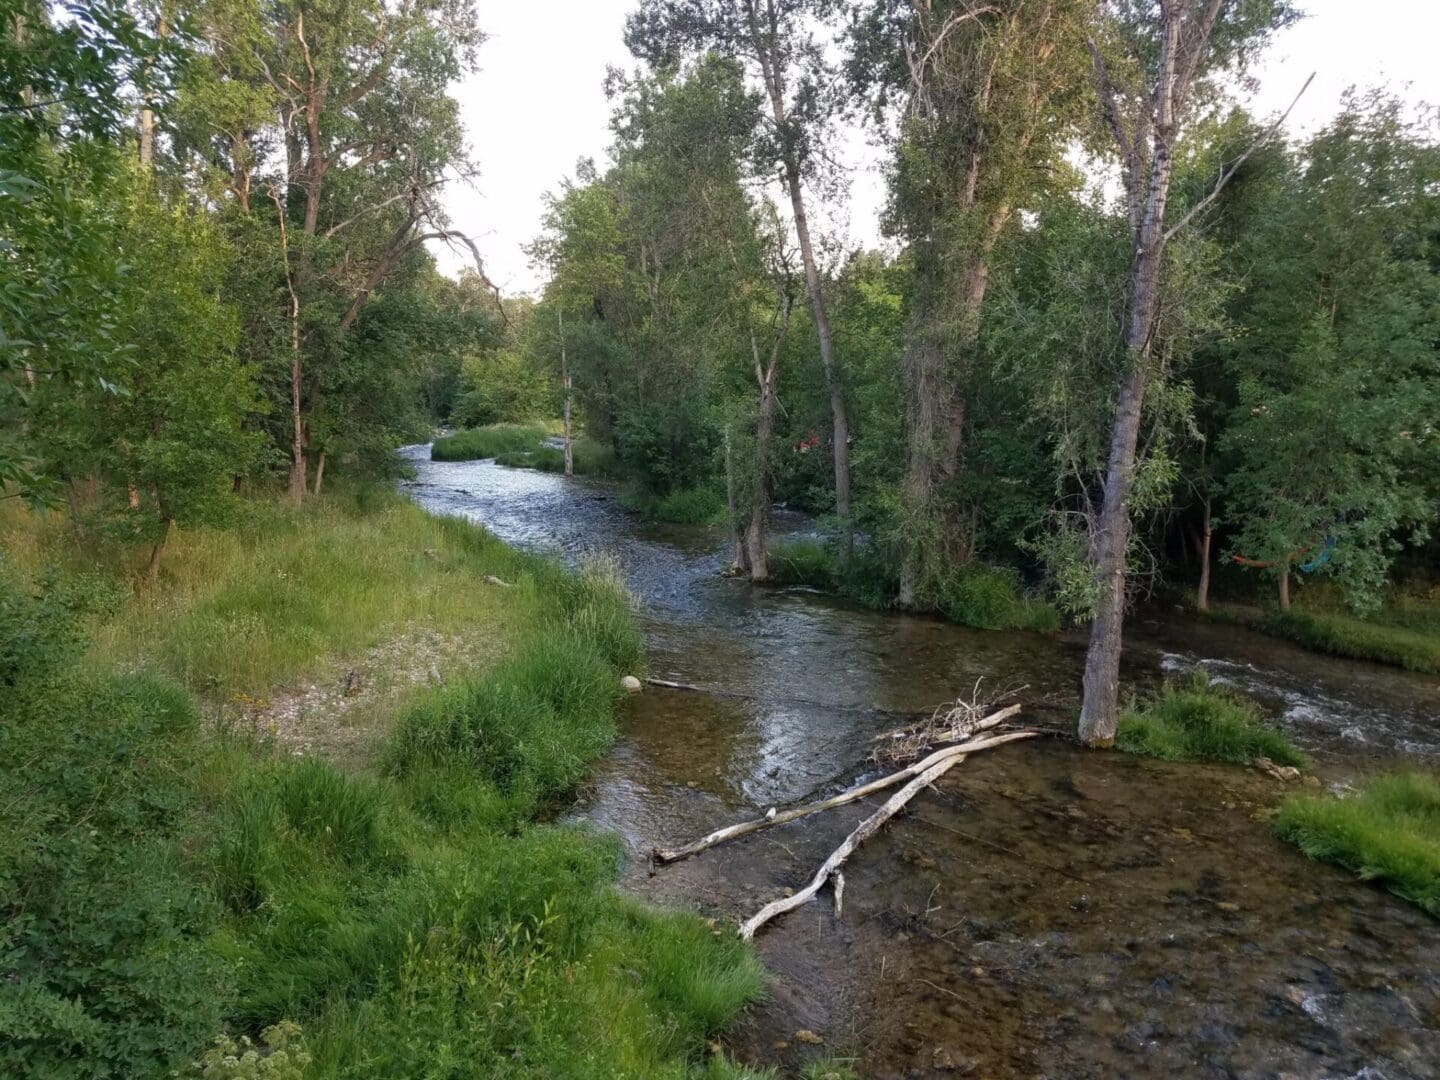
[1115,671,1308,768]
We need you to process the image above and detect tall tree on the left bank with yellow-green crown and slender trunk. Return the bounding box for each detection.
[187,0,482,503]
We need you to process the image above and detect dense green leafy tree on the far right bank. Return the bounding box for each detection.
[1221,95,1440,612]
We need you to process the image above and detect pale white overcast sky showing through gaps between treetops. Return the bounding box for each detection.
[436,0,1440,294]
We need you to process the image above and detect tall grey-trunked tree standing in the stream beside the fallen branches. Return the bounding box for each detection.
[1080,0,1293,746]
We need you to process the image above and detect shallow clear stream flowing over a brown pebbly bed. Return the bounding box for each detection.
[406,446,1440,1080]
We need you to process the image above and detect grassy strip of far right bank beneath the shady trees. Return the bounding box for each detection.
[1207,596,1440,674]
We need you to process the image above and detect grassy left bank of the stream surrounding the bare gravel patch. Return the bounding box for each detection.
[0,495,762,1077]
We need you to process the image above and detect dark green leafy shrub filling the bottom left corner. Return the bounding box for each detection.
[0,586,229,1079]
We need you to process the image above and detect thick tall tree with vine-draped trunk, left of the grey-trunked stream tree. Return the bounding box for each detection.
[851,0,1087,606]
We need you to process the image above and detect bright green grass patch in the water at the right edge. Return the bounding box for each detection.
[1274,772,1440,919]
